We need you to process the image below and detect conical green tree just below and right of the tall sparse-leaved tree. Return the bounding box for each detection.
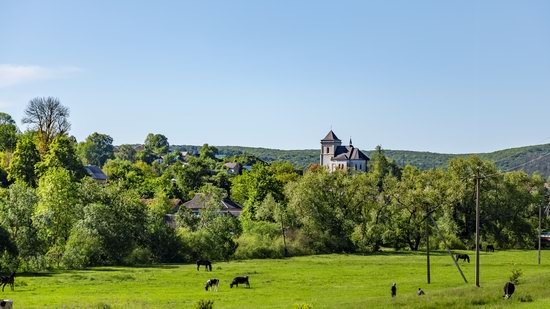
[36,135,86,179]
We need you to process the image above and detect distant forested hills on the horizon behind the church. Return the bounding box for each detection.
[177,144,550,176]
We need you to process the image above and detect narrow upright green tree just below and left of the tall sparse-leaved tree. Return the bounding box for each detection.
[8,134,40,187]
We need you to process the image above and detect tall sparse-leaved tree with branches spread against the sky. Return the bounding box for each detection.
[23,97,71,153]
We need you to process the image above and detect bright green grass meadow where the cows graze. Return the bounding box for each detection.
[2,251,550,308]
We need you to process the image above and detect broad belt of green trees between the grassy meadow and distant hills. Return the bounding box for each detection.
[0,98,548,270]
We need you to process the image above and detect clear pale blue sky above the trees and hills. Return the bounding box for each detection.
[0,0,550,153]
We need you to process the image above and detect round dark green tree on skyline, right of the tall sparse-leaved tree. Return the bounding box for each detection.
[78,132,114,167]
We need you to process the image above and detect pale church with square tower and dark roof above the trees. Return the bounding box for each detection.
[320,130,370,172]
